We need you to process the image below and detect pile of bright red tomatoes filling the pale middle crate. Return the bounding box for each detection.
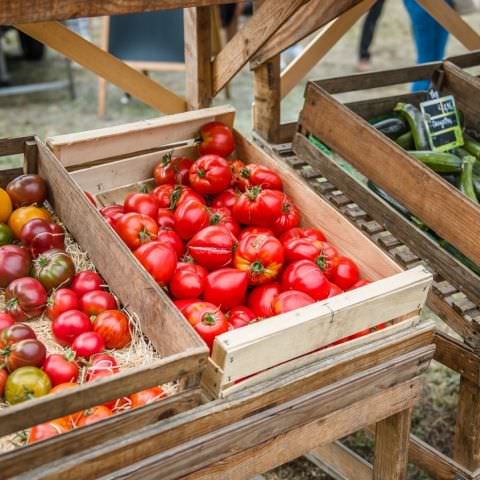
[100,122,382,348]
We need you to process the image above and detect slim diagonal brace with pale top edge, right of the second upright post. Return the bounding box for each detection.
[280,0,375,98]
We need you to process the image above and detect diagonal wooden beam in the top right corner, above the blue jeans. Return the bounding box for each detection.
[417,0,480,50]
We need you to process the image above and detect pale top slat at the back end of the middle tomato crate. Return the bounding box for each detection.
[47,105,235,167]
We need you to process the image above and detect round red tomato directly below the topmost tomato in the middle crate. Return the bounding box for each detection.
[189,155,232,195]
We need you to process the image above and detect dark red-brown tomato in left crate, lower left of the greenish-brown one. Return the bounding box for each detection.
[5,277,48,322]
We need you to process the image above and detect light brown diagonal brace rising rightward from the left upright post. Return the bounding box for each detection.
[213,0,306,95]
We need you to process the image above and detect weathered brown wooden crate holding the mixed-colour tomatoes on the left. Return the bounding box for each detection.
[0,137,208,448]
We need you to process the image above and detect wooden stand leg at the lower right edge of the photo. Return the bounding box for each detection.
[453,377,480,471]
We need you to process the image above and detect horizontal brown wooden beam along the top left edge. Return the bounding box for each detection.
[0,0,242,25]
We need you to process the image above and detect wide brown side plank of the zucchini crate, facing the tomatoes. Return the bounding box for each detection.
[301,84,480,263]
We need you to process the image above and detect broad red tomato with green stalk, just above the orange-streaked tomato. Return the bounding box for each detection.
[232,186,284,228]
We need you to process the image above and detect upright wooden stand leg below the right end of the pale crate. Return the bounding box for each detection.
[373,408,412,480]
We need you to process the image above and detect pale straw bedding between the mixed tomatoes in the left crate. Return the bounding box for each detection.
[0,202,178,453]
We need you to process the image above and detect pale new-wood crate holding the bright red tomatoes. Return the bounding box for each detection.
[47,107,431,396]
